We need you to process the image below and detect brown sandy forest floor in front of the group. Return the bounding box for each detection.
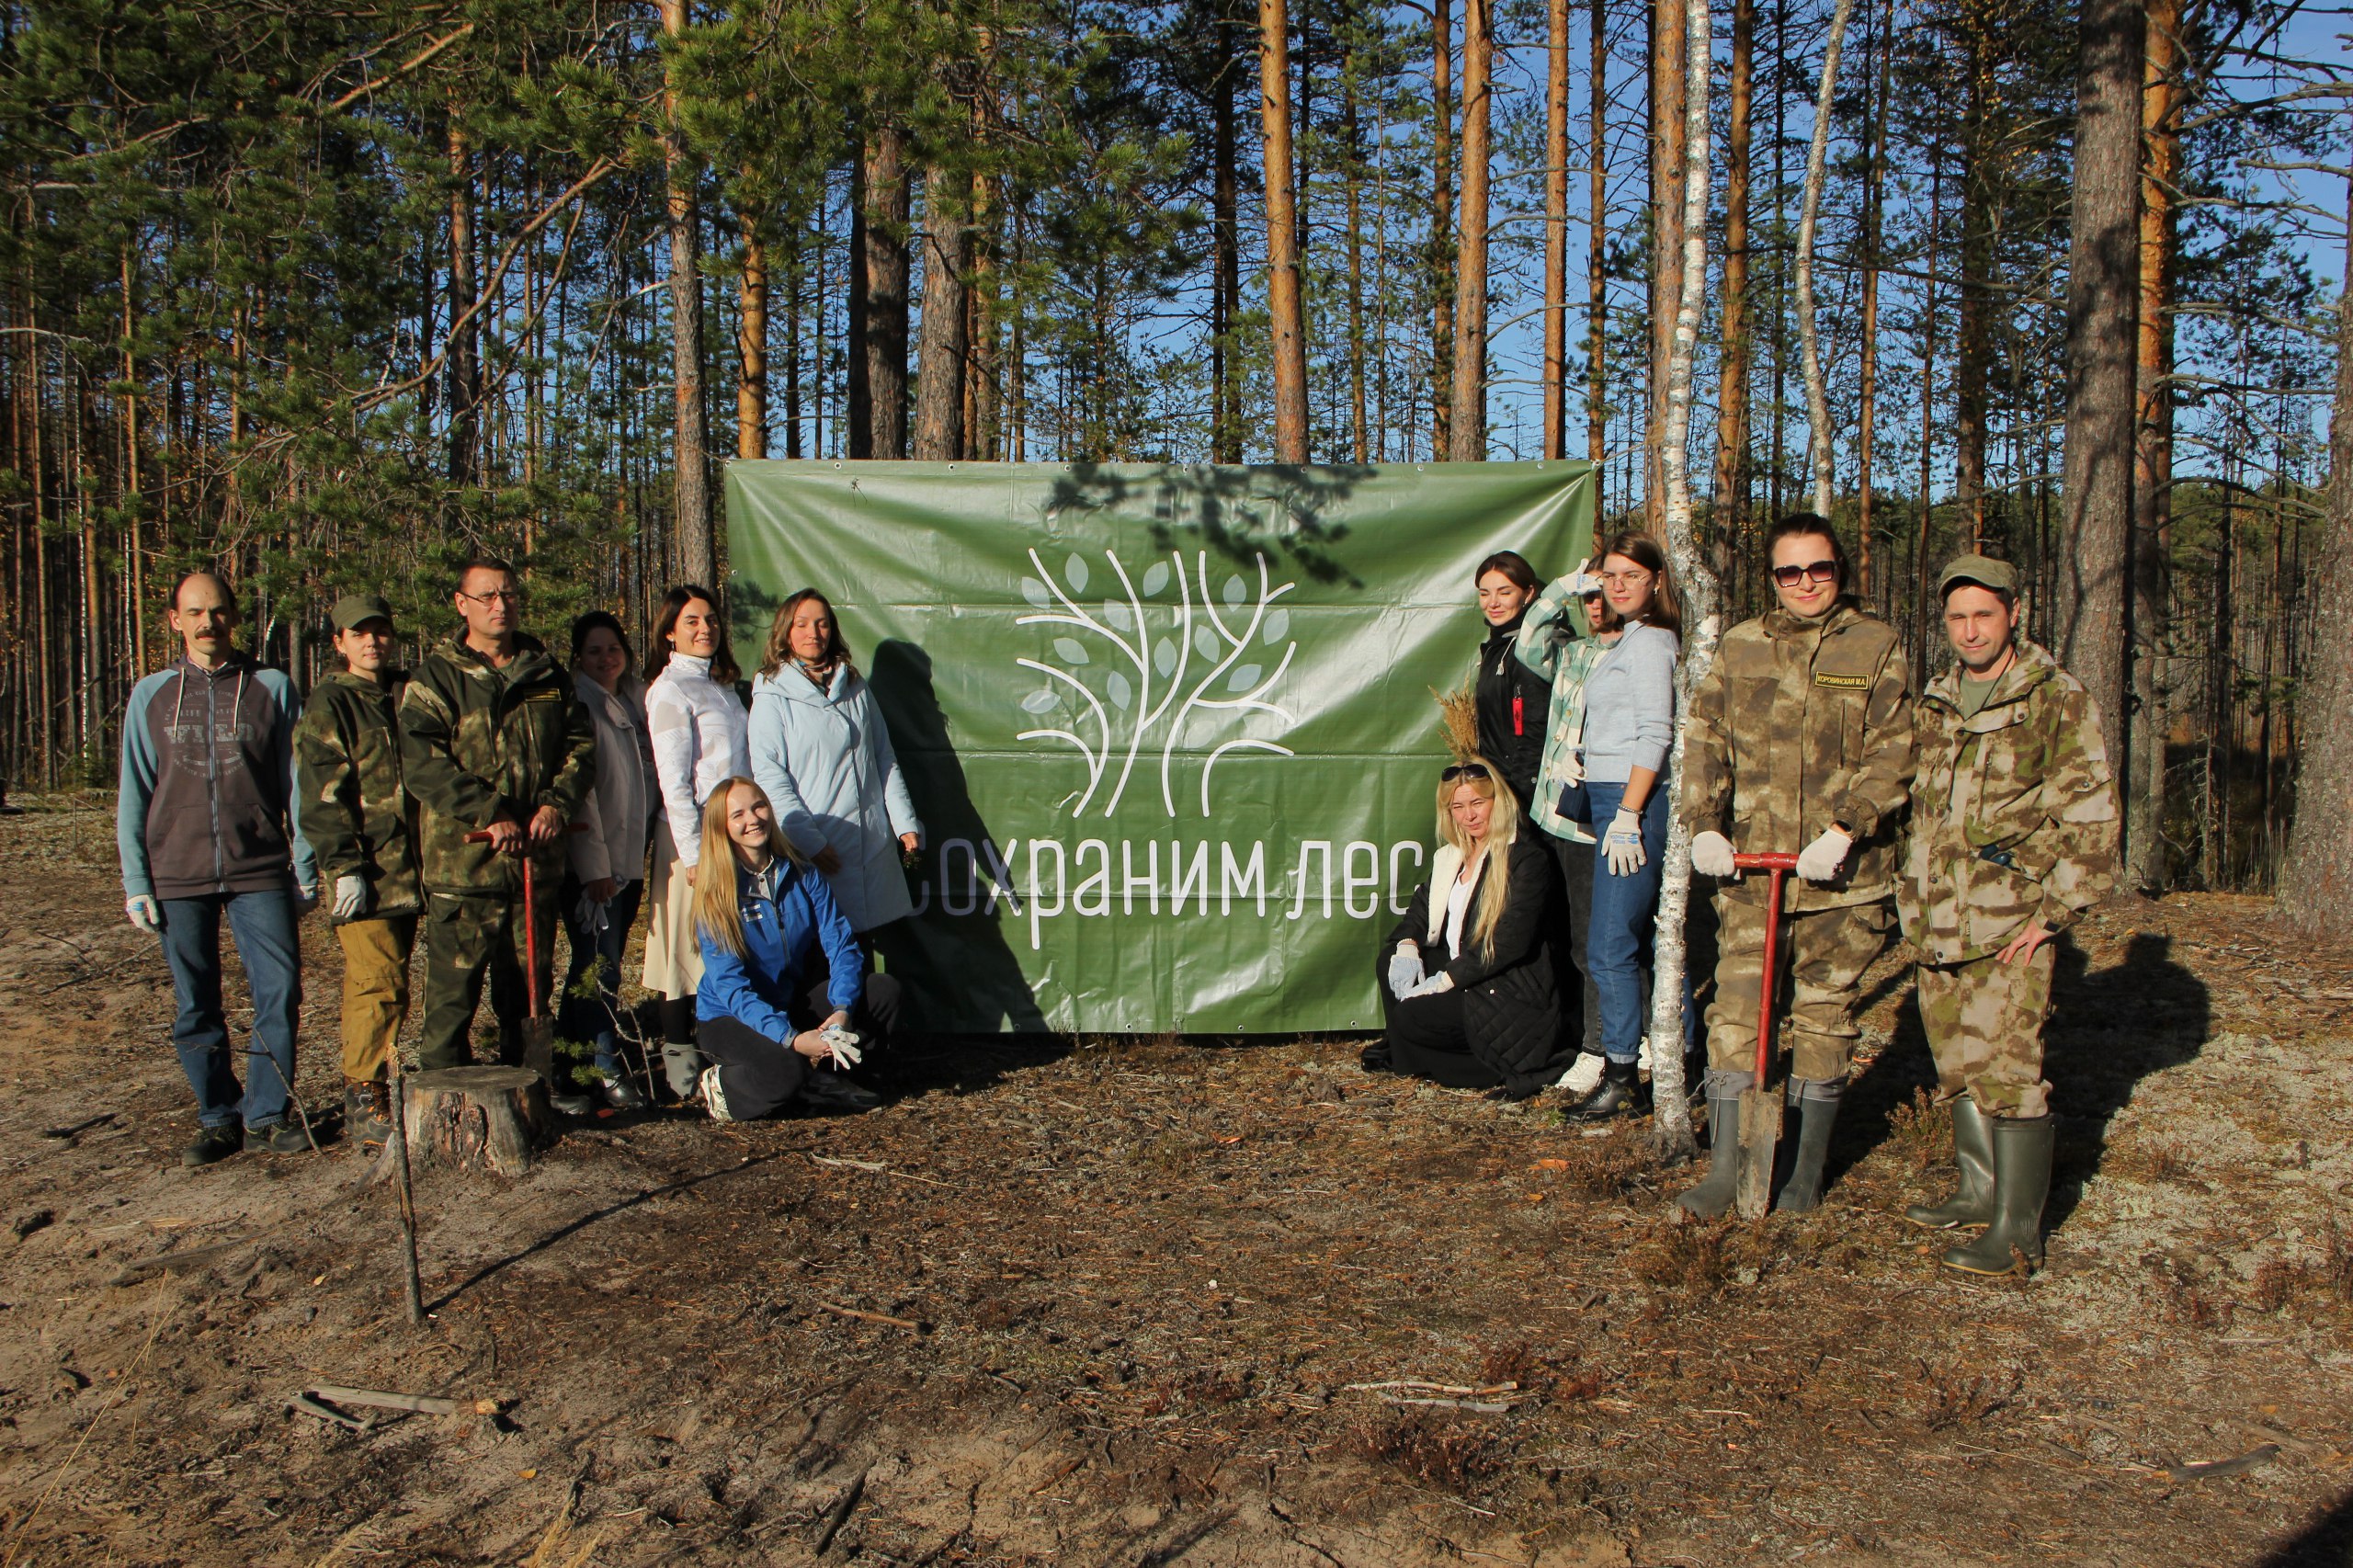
[0,801,2353,1568]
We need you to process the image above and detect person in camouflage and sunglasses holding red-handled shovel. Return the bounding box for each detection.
[1677,513,1913,1220]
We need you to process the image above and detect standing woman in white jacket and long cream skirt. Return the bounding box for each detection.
[644,584,751,1099]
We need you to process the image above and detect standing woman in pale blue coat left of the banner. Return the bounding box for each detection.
[751,588,923,927]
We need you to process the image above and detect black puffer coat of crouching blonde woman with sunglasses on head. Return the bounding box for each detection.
[1377,826,1574,1095]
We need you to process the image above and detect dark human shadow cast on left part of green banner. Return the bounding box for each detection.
[866,638,1059,1055]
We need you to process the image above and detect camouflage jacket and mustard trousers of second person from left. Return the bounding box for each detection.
[294,671,424,1083]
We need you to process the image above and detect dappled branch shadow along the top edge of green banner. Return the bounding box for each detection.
[1047,464,1374,588]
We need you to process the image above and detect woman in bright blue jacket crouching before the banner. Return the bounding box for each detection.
[694,779,899,1120]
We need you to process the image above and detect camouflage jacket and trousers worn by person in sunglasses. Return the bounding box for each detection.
[1682,598,1913,1087]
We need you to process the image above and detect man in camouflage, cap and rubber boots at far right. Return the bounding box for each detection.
[1896,556,2118,1274]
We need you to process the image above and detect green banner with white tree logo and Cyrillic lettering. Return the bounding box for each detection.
[727,461,1593,1034]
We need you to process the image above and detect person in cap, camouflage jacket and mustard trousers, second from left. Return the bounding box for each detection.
[294,594,424,1144]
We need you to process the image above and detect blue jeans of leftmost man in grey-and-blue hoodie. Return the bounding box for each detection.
[163,888,301,1128]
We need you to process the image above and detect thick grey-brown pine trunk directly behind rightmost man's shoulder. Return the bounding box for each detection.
[2056,0,2143,756]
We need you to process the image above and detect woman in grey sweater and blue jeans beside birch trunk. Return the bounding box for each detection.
[1570,532,1682,1120]
